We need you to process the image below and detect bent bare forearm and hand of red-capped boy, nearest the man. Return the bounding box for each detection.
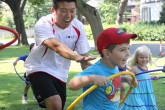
[68,75,109,90]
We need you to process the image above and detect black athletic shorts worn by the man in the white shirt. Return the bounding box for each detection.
[28,72,66,107]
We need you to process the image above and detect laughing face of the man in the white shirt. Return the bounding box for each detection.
[52,2,76,29]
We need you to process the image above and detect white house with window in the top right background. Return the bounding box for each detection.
[140,0,163,22]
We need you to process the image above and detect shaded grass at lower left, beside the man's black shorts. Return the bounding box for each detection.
[0,73,43,110]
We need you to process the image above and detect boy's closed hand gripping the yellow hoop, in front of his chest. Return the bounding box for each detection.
[92,75,109,87]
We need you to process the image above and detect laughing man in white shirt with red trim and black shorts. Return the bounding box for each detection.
[25,0,94,110]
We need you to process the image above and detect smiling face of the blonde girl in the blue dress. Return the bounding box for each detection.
[137,52,149,67]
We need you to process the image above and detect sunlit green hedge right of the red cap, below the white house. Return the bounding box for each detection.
[119,22,165,41]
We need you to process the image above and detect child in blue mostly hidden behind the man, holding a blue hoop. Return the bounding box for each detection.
[13,43,34,104]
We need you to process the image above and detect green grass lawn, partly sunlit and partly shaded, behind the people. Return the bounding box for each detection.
[0,46,165,110]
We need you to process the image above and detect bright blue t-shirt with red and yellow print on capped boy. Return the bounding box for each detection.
[75,60,121,110]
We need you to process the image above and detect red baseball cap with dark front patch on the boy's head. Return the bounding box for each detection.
[97,28,137,53]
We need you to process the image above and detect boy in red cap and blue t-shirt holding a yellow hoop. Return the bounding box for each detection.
[68,28,137,110]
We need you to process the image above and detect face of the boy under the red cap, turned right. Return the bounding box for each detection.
[106,43,130,68]
